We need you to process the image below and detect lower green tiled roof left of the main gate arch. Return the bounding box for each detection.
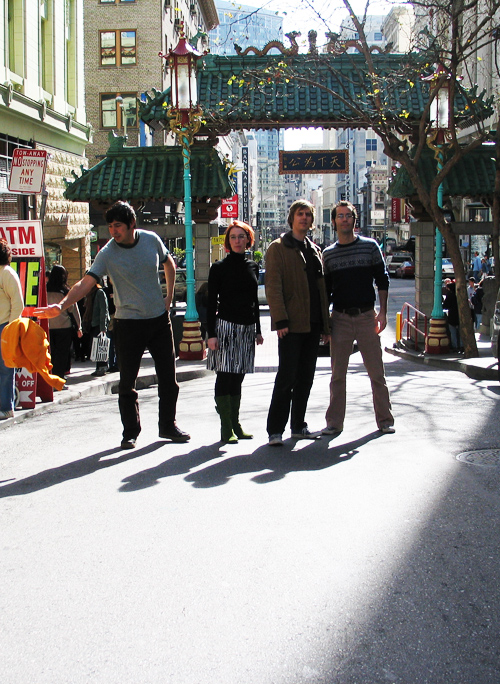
[64,137,234,203]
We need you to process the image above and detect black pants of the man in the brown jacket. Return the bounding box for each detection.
[267,325,320,435]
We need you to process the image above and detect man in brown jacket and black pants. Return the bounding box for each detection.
[266,200,329,446]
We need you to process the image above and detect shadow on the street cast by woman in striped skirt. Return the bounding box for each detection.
[118,442,226,492]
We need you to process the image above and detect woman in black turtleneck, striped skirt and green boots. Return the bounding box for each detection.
[207,221,264,444]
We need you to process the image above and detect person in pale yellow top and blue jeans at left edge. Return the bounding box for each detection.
[0,240,24,420]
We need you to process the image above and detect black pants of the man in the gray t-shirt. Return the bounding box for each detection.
[114,312,179,439]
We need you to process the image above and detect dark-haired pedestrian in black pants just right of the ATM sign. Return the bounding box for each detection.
[47,264,83,379]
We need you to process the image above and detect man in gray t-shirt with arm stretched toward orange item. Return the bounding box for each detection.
[34,202,190,449]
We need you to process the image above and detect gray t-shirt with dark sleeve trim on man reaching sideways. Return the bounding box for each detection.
[89,229,169,320]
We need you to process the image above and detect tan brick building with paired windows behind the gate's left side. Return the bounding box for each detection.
[84,0,218,166]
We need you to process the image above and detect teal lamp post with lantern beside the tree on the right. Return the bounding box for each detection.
[423,65,452,354]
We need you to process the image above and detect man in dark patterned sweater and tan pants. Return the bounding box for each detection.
[323,201,395,435]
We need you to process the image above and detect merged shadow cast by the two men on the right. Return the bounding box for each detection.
[184,430,382,488]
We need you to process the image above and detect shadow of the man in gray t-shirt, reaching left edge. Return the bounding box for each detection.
[0,442,165,499]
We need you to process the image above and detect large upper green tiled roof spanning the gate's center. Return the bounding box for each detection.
[139,54,491,129]
